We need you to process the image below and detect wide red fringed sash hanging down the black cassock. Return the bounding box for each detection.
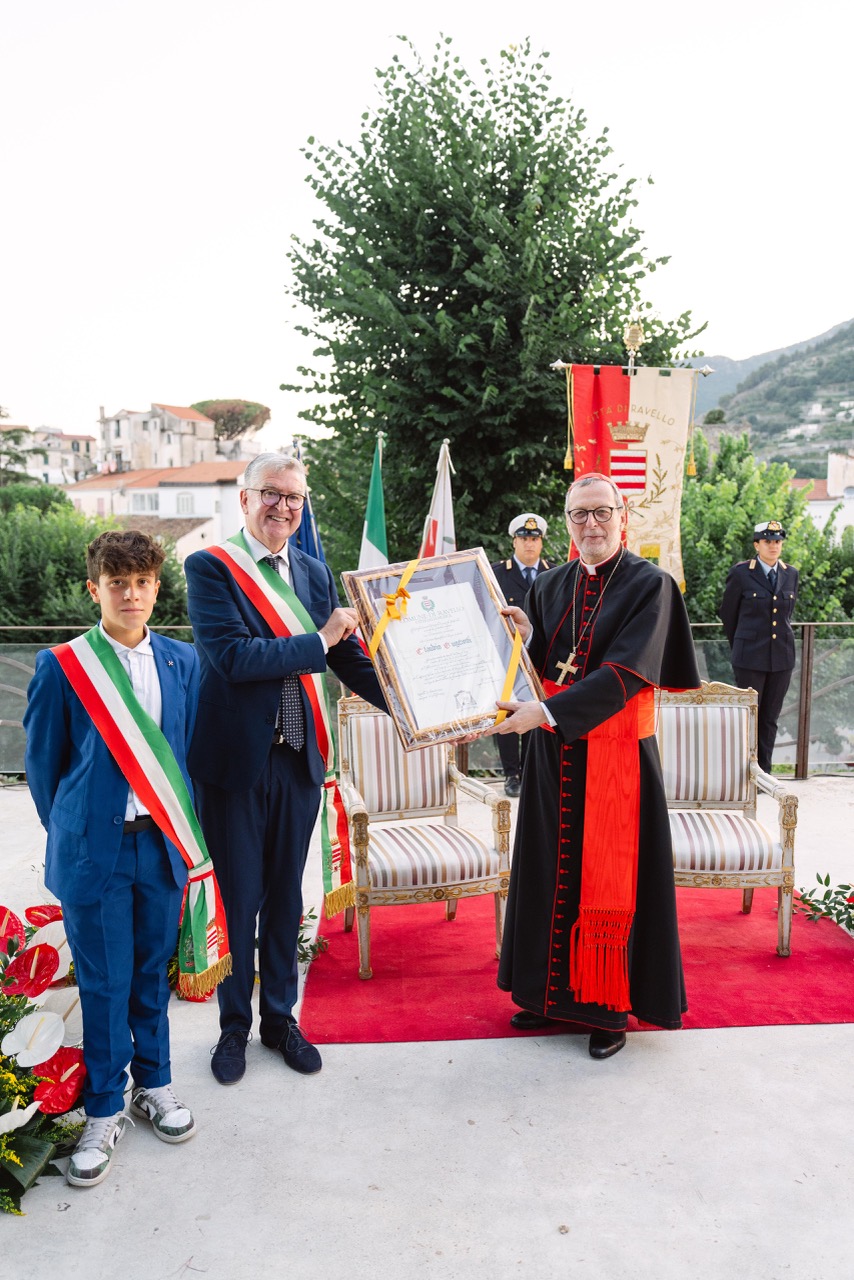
[543,680,656,1011]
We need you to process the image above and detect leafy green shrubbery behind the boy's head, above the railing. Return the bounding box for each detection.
[0,504,187,634]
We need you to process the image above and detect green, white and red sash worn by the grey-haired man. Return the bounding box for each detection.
[207,532,356,916]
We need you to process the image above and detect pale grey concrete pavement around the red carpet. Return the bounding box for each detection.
[0,777,854,1280]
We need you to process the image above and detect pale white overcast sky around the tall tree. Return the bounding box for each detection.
[0,0,854,442]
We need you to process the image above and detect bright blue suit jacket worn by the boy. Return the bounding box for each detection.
[24,632,198,906]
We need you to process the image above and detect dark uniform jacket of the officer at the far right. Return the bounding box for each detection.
[718,559,798,671]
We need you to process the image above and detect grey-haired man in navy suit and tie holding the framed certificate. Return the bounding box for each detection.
[184,453,385,1084]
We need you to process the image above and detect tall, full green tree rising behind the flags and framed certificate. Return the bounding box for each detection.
[284,38,706,567]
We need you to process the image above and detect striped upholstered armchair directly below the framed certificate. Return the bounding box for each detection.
[338,698,510,978]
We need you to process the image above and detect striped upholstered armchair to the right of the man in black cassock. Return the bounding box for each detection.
[657,682,798,956]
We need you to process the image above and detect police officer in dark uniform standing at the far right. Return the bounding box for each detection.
[718,520,798,773]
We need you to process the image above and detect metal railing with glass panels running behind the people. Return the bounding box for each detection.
[0,622,854,778]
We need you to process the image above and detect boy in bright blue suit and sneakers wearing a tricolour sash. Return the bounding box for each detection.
[24,530,198,1187]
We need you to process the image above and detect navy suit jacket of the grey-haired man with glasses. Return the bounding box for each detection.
[184,543,385,791]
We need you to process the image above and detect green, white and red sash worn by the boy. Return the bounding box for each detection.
[52,627,232,996]
